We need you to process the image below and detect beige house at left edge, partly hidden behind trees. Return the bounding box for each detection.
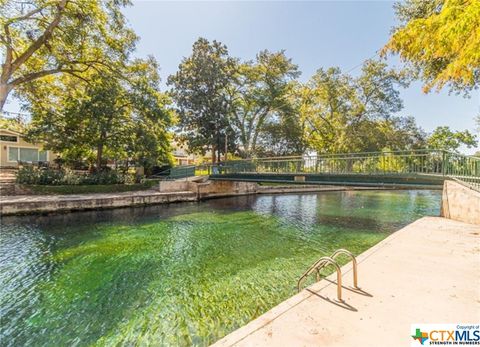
[0,129,57,168]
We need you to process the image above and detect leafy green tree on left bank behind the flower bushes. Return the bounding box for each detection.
[28,58,172,169]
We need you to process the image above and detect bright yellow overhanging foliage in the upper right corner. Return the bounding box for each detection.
[383,0,480,93]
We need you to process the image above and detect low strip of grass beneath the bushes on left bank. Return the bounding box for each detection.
[22,180,158,195]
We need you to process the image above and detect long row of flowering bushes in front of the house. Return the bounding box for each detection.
[17,166,137,185]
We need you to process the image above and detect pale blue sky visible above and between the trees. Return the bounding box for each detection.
[5,1,480,152]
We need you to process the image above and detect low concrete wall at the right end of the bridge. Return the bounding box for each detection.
[441,180,480,224]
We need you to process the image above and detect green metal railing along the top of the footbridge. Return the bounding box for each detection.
[208,150,480,190]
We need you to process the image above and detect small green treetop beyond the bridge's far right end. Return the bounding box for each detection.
[427,126,478,151]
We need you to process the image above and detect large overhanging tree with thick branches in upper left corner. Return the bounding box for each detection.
[0,0,137,111]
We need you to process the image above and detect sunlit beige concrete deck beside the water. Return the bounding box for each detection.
[214,217,480,347]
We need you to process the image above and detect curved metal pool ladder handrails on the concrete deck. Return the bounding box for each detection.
[297,249,358,301]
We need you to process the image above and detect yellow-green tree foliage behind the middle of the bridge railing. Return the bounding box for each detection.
[293,60,424,153]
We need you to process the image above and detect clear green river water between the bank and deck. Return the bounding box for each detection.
[0,191,440,346]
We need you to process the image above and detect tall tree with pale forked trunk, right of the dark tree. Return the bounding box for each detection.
[232,50,300,157]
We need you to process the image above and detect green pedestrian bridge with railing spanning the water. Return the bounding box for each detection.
[203,150,480,190]
